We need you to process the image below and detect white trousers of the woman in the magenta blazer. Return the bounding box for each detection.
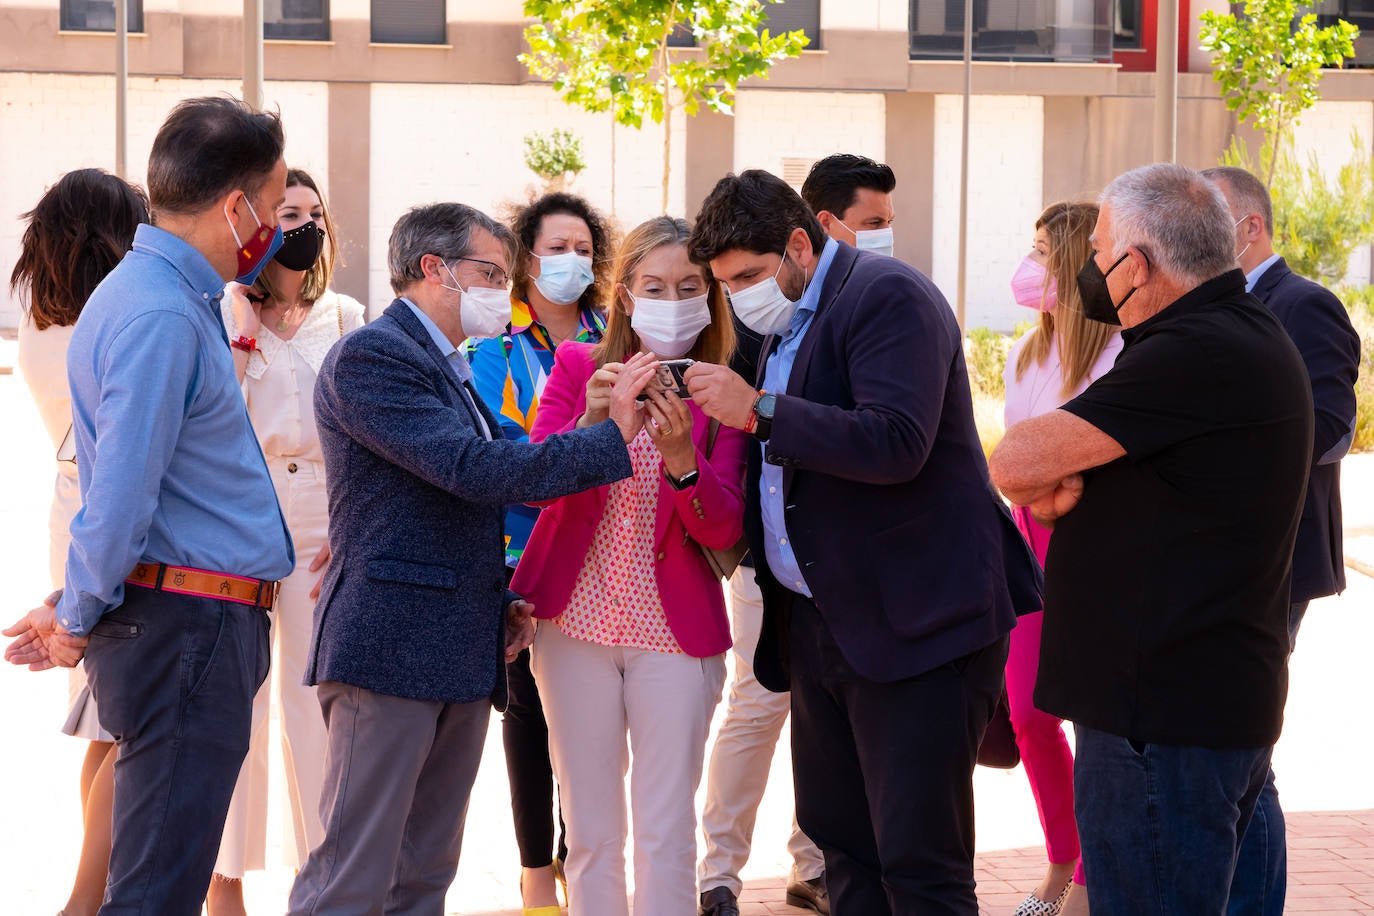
[530,621,725,916]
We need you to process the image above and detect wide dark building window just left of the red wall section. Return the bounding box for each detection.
[911,0,1110,62]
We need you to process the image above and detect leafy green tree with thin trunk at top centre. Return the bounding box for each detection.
[521,0,808,211]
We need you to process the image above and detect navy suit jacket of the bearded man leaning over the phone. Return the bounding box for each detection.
[745,243,1043,691]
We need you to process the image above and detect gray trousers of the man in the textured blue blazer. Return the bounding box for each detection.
[287,681,492,916]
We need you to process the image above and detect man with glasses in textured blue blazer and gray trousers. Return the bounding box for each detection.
[290,203,657,916]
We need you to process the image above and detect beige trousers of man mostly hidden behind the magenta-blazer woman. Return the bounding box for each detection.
[697,566,826,897]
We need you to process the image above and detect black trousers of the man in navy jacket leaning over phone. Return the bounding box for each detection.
[789,596,1007,916]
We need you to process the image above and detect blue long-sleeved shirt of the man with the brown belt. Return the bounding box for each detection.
[58,225,295,636]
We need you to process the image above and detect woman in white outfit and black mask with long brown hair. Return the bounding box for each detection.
[206,169,364,916]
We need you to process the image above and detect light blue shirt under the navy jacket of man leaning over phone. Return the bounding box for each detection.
[758,239,840,597]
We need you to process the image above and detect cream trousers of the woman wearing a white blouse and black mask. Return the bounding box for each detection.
[214,457,328,878]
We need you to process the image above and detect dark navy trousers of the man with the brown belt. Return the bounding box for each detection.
[85,586,269,916]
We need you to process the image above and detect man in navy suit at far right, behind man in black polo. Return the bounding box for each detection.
[1202,166,1360,916]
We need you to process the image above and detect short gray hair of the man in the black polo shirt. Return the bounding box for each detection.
[1098,162,1235,286]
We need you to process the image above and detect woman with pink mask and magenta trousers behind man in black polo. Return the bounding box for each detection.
[1004,203,1121,916]
